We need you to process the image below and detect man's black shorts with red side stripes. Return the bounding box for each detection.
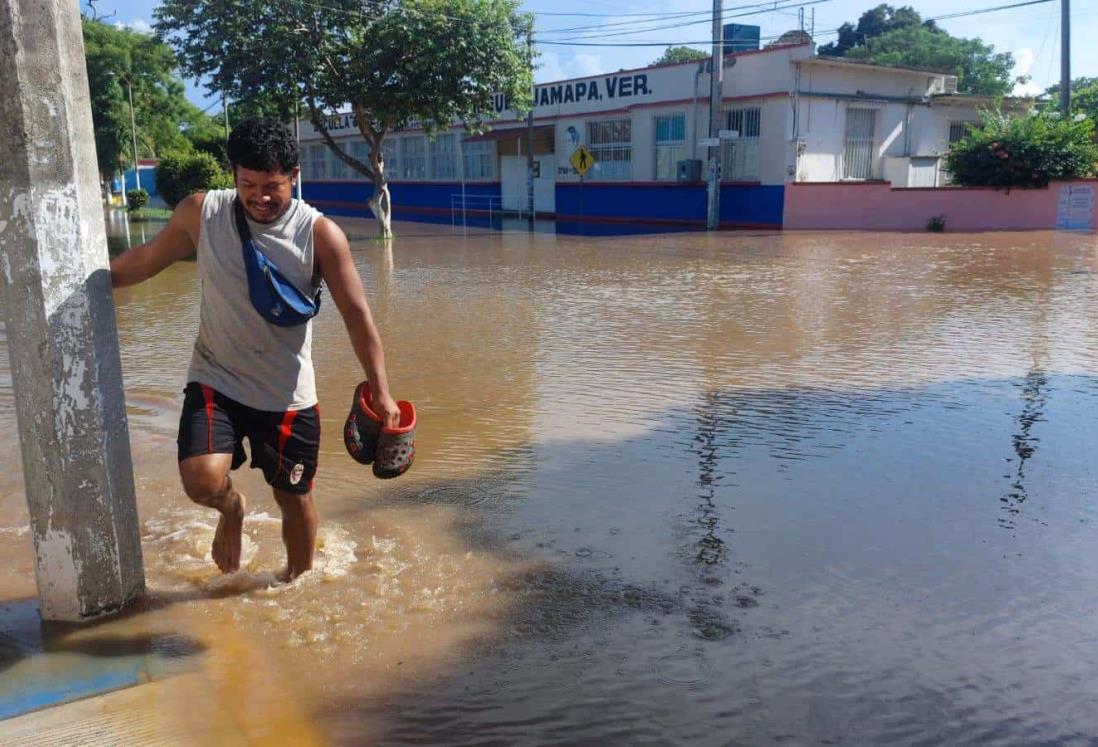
[177,381,321,494]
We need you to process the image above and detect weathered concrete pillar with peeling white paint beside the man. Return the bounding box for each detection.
[0,0,145,622]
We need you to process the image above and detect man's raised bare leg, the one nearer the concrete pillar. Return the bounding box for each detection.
[179,454,245,573]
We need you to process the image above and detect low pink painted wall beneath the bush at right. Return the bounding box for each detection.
[784,181,1094,231]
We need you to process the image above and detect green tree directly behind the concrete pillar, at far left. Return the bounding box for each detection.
[83,16,202,177]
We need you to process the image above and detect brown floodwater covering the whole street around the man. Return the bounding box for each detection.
[0,212,1098,745]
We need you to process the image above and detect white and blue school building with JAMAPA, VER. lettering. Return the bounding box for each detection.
[301,43,994,228]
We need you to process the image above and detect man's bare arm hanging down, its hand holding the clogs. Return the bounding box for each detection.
[313,218,401,426]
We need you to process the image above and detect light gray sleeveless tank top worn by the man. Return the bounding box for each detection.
[187,189,321,412]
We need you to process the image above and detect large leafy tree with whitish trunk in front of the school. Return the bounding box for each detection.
[155,0,533,236]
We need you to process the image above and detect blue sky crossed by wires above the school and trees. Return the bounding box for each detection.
[85,0,1098,109]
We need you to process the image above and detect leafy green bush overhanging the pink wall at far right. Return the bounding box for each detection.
[945,112,1098,188]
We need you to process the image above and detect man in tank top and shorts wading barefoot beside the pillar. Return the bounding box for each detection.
[111,120,400,580]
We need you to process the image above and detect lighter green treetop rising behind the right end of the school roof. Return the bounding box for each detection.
[847,26,1015,96]
